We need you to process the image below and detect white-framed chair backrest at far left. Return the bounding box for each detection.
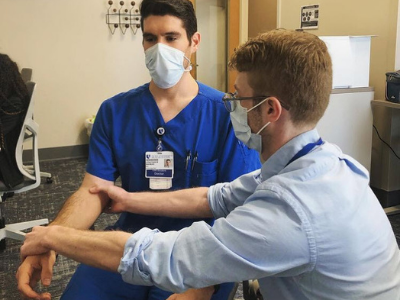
[14,81,41,193]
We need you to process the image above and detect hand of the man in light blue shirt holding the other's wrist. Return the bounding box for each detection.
[21,226,51,261]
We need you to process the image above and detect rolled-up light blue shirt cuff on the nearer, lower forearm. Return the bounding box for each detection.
[118,228,159,285]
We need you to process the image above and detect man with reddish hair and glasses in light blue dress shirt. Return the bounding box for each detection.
[21,30,400,300]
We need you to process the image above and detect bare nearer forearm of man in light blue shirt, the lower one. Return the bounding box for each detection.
[41,226,132,272]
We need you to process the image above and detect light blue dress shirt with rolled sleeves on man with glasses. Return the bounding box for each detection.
[119,130,400,300]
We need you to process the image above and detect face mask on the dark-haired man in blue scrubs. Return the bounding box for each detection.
[145,43,192,89]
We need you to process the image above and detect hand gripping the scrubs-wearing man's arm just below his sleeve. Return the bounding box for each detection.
[89,185,129,213]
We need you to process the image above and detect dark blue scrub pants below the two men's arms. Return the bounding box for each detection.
[60,264,234,300]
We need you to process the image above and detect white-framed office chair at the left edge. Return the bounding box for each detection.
[0,82,49,250]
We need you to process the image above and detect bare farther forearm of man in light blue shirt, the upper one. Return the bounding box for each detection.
[126,187,213,218]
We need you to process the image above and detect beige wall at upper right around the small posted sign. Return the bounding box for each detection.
[280,0,398,99]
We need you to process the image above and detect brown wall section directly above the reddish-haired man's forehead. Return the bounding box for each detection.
[248,0,277,38]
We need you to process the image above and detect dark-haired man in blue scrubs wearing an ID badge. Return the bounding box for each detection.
[18,0,260,300]
